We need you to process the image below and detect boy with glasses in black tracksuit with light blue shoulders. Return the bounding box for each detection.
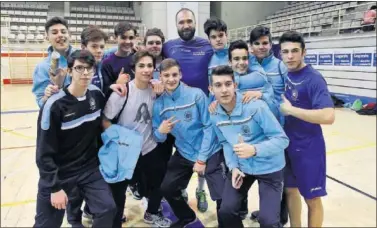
[34,50,116,227]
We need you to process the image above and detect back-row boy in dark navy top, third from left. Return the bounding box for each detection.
[101,22,136,97]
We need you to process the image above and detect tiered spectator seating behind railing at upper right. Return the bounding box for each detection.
[229,1,376,40]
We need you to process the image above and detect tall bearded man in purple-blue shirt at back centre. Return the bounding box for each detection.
[162,8,213,212]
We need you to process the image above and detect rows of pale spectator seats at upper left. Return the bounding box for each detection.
[1,2,141,43]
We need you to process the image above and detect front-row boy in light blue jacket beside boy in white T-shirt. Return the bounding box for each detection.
[153,58,225,227]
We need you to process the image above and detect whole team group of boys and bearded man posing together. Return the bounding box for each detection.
[32,8,335,227]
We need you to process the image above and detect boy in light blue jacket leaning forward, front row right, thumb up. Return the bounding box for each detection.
[211,66,288,227]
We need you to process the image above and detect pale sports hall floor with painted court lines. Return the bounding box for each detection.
[1,85,376,227]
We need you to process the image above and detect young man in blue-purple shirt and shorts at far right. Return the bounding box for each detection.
[279,31,335,227]
